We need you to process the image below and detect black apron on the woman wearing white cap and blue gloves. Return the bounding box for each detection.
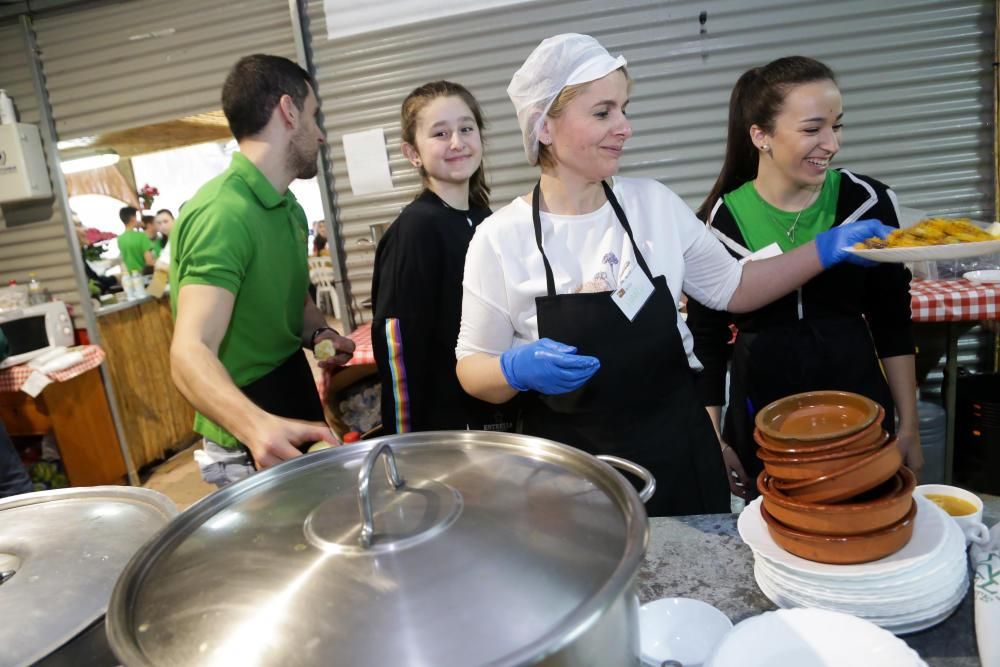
[519,183,730,516]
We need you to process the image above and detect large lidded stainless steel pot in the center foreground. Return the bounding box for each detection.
[107,431,654,667]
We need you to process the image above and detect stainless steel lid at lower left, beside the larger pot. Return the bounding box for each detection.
[0,486,177,666]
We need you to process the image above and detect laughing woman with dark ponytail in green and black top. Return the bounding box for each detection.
[688,57,923,497]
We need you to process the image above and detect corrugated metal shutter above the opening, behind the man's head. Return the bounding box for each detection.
[35,0,295,141]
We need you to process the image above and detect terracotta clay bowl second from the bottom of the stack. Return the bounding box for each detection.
[757,466,917,535]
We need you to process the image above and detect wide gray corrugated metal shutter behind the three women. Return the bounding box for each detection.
[306,0,995,317]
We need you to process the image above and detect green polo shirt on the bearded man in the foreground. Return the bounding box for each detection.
[170,153,309,446]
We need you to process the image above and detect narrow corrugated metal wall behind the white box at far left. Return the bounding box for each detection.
[0,24,86,328]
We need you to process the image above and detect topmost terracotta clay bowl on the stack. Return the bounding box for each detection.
[754,391,879,443]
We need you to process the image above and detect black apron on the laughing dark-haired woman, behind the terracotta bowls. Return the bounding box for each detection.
[722,316,896,496]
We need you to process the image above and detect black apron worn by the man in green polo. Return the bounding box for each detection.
[240,348,326,460]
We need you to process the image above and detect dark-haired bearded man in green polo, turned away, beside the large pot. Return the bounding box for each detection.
[170,55,354,486]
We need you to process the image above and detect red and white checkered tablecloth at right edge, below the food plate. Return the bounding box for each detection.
[910,279,1000,322]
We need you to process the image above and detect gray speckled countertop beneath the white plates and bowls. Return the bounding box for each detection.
[639,496,1000,667]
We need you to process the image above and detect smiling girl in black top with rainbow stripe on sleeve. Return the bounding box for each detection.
[372,81,513,434]
